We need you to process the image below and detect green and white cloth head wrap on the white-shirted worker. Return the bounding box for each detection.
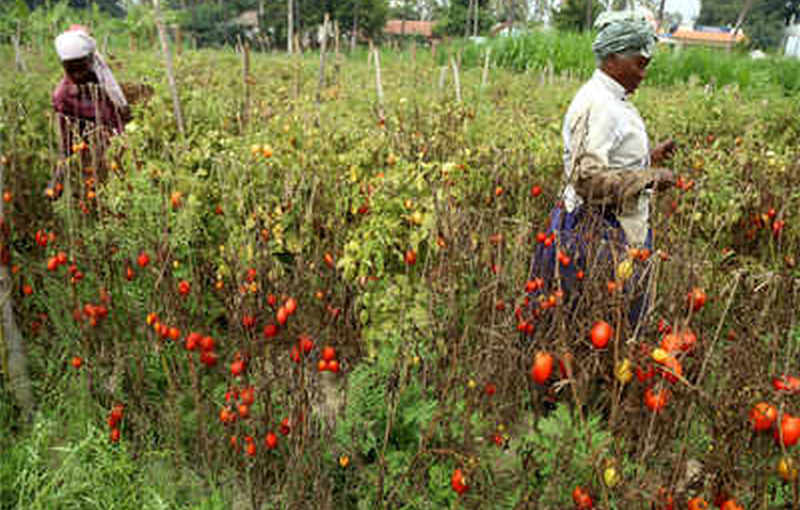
[592,10,656,60]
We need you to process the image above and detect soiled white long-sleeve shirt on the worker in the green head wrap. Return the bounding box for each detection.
[562,69,654,245]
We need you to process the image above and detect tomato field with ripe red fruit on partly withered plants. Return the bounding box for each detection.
[0,36,800,509]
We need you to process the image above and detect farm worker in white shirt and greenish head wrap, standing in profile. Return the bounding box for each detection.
[532,10,675,322]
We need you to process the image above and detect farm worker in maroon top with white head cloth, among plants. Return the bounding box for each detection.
[48,25,131,196]
